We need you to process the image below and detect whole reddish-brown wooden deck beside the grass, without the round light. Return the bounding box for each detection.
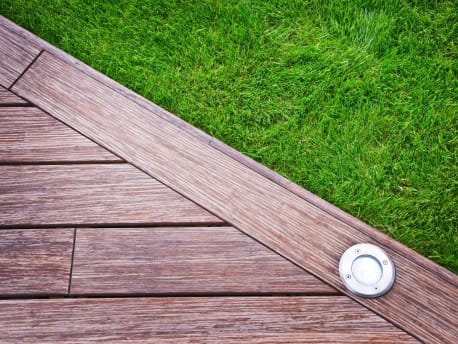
[0,17,458,343]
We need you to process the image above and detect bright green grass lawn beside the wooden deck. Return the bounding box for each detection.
[0,0,458,273]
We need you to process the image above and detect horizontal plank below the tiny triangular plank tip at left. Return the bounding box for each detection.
[0,107,122,163]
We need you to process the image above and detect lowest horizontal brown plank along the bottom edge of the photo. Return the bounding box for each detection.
[0,296,417,344]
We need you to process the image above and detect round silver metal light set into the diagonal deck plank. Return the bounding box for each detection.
[339,244,396,298]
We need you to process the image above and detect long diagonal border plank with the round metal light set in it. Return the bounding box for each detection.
[14,49,458,343]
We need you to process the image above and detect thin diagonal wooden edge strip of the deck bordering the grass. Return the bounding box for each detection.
[0,16,456,284]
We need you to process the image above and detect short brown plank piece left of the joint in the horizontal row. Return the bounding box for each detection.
[0,228,74,296]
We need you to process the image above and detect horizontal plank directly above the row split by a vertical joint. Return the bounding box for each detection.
[0,164,222,227]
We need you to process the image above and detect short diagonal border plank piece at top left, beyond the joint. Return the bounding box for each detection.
[0,25,40,88]
